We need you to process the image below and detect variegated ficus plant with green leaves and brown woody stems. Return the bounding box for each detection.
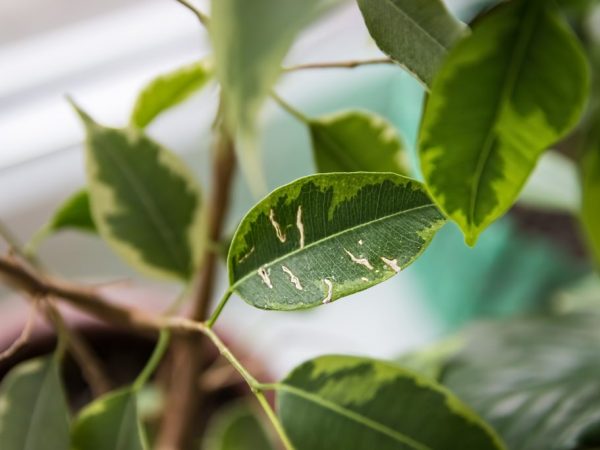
[0,0,600,450]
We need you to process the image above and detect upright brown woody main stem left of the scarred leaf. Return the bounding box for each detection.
[157,118,235,450]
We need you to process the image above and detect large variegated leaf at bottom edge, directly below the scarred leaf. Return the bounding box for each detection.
[276,356,504,450]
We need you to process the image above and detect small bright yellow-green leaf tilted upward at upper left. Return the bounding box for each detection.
[131,60,213,128]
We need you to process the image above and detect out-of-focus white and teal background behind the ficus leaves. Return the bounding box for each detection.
[0,0,598,382]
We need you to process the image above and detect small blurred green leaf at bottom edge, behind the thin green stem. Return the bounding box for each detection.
[202,402,275,450]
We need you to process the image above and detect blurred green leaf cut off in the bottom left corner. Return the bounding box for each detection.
[0,357,70,450]
